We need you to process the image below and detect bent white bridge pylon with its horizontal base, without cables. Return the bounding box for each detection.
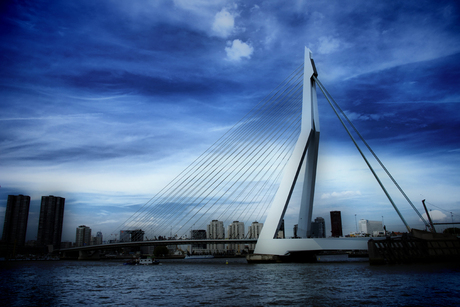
[254,48,368,255]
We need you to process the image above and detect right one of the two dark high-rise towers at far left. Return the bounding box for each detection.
[37,195,65,248]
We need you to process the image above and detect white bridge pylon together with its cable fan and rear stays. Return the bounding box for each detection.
[113,48,430,255]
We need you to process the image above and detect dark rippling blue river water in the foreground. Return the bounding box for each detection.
[0,259,460,306]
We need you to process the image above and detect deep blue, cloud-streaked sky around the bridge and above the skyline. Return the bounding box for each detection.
[0,0,460,241]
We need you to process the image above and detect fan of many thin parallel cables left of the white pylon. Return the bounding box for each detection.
[112,65,303,237]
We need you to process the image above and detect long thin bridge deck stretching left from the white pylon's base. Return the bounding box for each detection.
[55,239,257,252]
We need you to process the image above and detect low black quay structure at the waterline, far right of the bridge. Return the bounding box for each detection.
[367,229,460,265]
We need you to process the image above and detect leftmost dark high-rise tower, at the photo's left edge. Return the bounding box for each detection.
[2,195,30,246]
